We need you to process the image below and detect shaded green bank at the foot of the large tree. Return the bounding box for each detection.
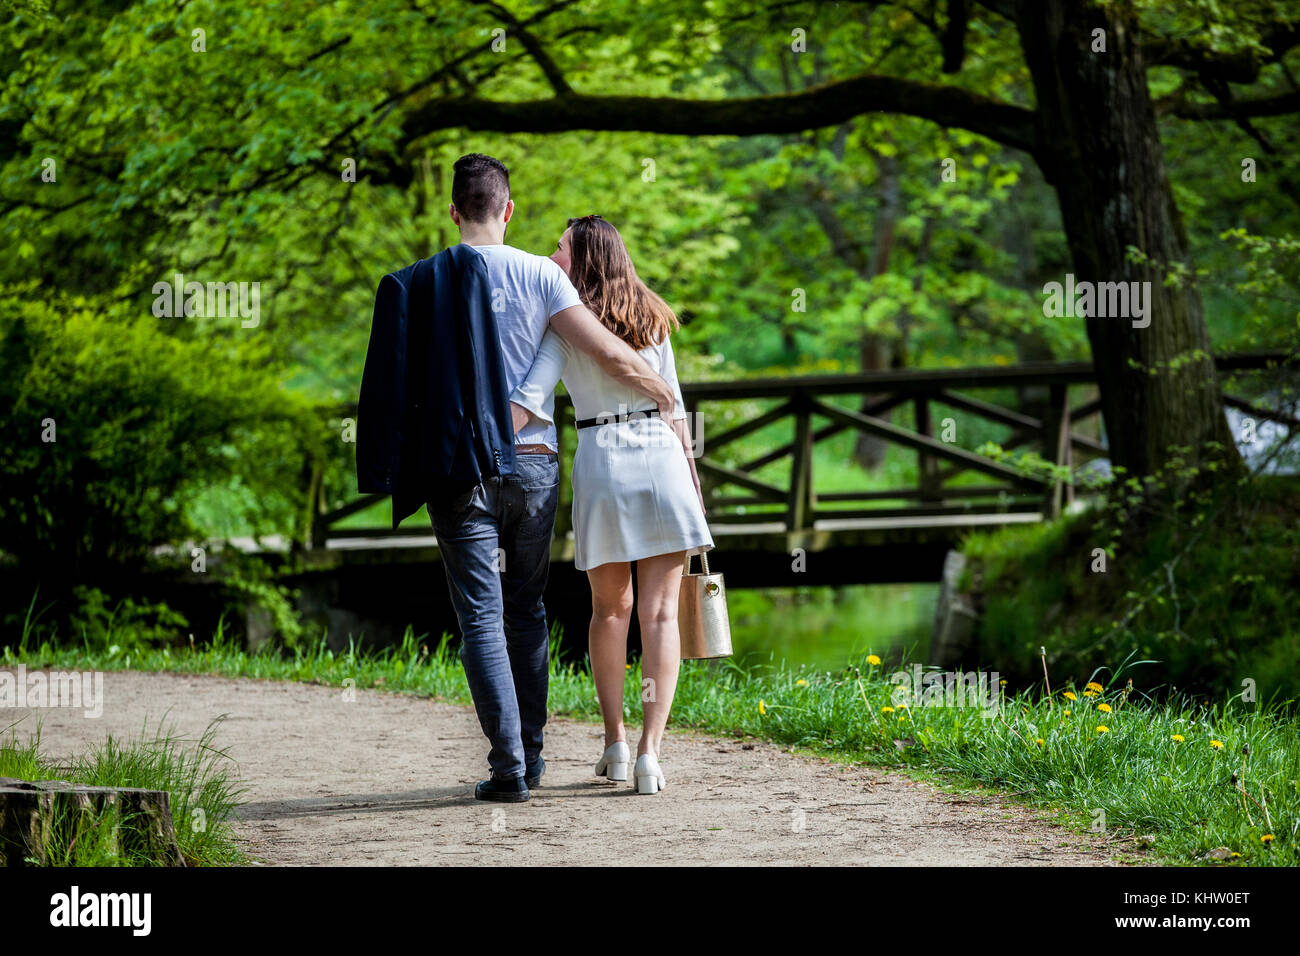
[962,479,1300,700]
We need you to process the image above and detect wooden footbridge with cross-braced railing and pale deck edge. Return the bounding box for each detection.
[299,352,1297,587]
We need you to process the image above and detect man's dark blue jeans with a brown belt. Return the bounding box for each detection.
[429,454,560,778]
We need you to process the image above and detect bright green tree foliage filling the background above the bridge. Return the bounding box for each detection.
[0,0,1300,655]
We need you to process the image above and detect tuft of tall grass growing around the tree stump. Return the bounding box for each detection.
[0,721,247,866]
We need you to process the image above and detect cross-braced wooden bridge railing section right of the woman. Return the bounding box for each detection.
[684,365,1105,531]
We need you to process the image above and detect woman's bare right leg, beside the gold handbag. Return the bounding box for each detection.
[637,551,684,757]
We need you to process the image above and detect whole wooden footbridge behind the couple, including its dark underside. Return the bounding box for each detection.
[169,352,1300,657]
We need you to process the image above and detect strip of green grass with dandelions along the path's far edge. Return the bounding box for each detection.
[5,632,1300,866]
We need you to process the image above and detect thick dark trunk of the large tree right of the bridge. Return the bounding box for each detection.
[1017,0,1240,475]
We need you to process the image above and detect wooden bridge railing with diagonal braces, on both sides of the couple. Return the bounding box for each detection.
[303,352,1297,548]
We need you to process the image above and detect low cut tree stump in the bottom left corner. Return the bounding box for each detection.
[0,777,185,866]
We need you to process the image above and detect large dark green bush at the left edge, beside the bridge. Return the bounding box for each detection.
[0,286,324,652]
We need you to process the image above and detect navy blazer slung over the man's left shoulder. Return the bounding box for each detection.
[356,243,515,528]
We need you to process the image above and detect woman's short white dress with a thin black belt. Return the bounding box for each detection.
[510,330,714,571]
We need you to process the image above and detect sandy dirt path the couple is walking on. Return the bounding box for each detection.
[3,672,1128,866]
